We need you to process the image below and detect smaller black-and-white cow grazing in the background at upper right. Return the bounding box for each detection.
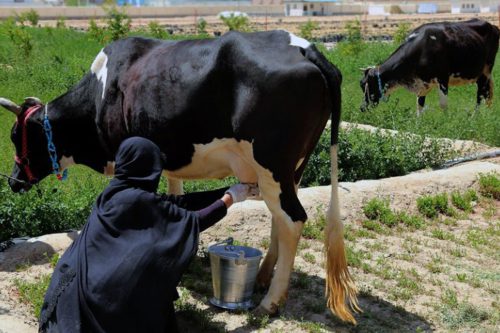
[360,19,500,114]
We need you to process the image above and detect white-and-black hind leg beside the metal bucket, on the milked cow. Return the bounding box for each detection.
[257,168,307,314]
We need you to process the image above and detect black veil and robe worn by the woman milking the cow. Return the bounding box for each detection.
[40,138,199,333]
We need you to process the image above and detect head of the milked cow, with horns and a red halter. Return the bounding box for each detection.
[0,97,52,192]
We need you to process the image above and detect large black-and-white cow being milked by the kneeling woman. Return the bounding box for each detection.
[0,31,358,322]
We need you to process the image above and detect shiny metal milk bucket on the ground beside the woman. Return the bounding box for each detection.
[208,238,262,310]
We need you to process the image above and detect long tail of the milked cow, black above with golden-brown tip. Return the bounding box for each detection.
[305,45,361,324]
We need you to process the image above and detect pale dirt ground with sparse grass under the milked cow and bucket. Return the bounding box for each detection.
[0,149,500,333]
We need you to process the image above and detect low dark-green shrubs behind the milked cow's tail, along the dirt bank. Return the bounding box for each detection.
[301,128,454,187]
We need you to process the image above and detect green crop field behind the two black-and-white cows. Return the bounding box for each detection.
[0,22,500,240]
